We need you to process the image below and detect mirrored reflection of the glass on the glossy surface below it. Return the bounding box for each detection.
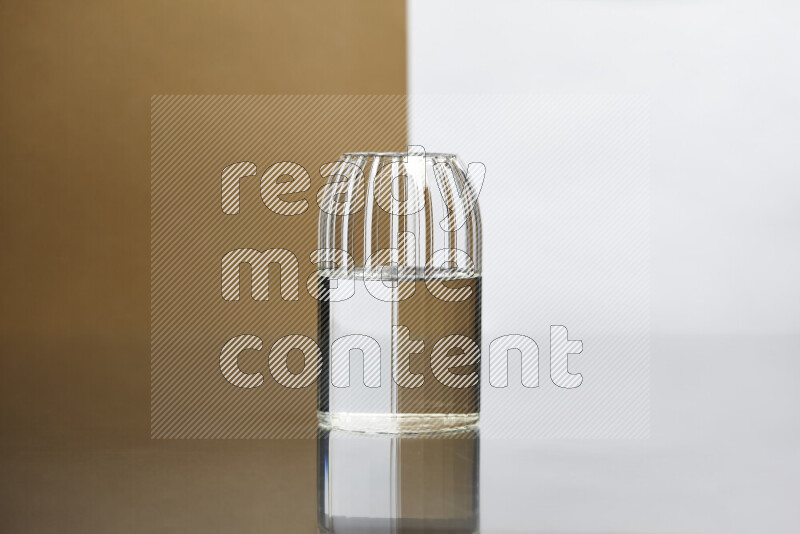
[317,427,480,534]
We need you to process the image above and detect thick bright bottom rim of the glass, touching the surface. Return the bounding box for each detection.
[317,412,480,434]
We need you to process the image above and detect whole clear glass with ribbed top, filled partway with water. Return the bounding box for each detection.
[316,147,483,432]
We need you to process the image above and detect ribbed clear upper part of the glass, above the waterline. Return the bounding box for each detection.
[319,152,481,273]
